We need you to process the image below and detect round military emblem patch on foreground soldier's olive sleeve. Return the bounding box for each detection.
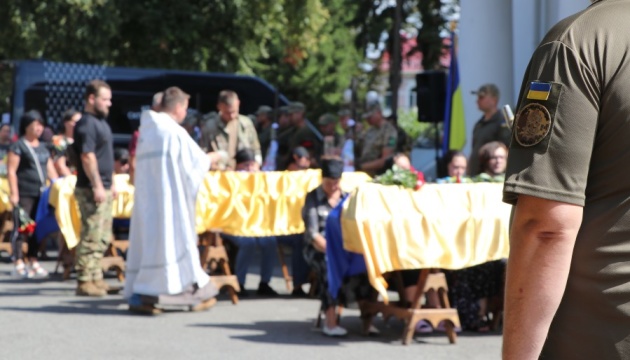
[514,103,551,146]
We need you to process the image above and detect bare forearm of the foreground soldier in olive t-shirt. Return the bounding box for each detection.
[503,198,582,360]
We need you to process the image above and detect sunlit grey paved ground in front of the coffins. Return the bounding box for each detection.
[0,254,501,360]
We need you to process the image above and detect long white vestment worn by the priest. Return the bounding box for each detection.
[124,110,210,298]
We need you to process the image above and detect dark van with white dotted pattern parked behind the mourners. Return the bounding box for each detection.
[10,60,296,146]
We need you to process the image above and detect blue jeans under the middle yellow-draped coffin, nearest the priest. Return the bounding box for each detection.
[221,234,277,285]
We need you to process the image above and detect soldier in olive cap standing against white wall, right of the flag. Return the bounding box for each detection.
[468,84,510,176]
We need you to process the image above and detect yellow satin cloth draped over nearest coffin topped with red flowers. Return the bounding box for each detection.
[341,183,511,298]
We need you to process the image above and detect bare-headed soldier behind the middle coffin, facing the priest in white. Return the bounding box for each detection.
[199,90,262,170]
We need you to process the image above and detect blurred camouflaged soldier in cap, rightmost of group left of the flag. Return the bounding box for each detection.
[358,103,398,176]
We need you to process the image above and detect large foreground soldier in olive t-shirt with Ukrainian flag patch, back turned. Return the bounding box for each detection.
[503,0,630,359]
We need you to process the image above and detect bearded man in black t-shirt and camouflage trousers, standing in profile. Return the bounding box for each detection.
[72,80,114,296]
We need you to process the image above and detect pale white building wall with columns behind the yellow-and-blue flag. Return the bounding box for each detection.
[459,0,590,154]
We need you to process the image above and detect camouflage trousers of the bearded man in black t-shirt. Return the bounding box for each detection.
[74,188,113,281]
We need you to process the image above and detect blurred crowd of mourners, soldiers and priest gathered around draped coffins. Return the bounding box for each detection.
[0,76,507,336]
